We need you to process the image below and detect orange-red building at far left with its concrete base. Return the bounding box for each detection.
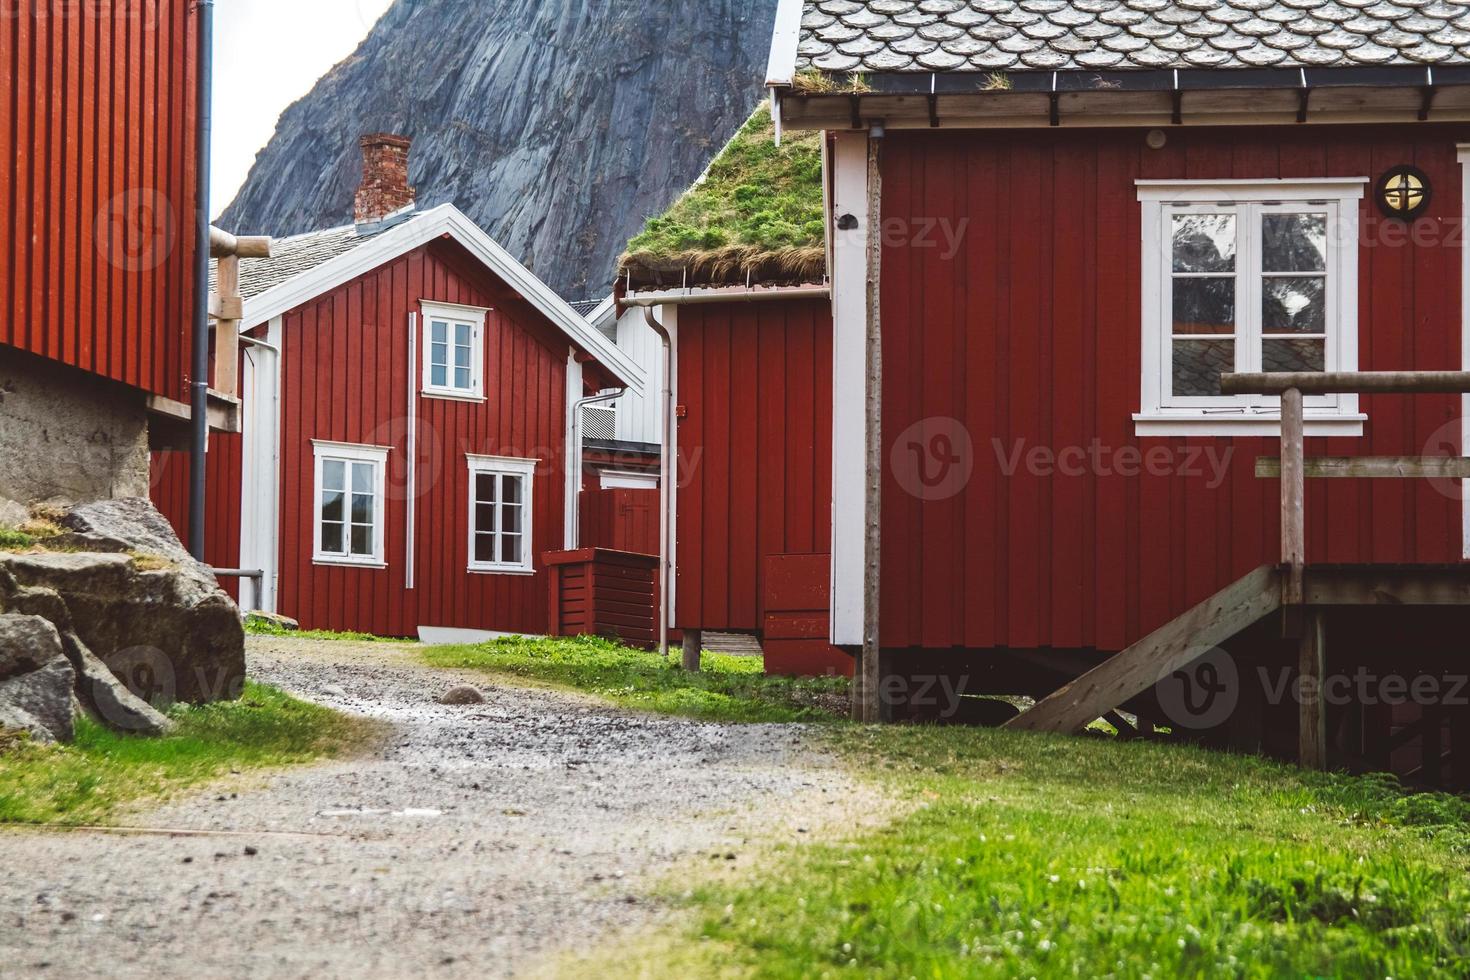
[0,0,231,513]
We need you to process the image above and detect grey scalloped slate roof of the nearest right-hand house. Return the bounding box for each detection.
[797,0,1470,72]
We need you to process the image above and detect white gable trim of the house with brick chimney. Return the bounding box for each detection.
[241,204,645,392]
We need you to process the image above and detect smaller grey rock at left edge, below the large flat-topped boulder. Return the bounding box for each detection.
[0,614,76,742]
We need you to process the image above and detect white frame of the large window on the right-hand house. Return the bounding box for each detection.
[1133,178,1367,436]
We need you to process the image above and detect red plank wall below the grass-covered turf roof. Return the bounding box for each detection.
[675,300,832,630]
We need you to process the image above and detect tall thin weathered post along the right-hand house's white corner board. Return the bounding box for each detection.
[853,134,885,724]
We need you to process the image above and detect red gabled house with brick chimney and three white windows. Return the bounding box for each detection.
[159,137,642,636]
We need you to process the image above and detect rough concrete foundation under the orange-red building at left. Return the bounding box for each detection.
[0,347,148,516]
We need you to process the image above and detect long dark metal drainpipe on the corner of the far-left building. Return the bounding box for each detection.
[188,0,215,561]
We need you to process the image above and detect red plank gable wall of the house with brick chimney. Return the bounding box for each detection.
[278,242,567,636]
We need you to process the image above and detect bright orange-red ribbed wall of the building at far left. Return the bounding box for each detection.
[0,0,197,401]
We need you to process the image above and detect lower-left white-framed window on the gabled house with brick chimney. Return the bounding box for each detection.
[312,439,388,567]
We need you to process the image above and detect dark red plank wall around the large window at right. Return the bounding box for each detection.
[876,126,1470,649]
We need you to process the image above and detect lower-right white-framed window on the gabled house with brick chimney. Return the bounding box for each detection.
[466,455,537,574]
